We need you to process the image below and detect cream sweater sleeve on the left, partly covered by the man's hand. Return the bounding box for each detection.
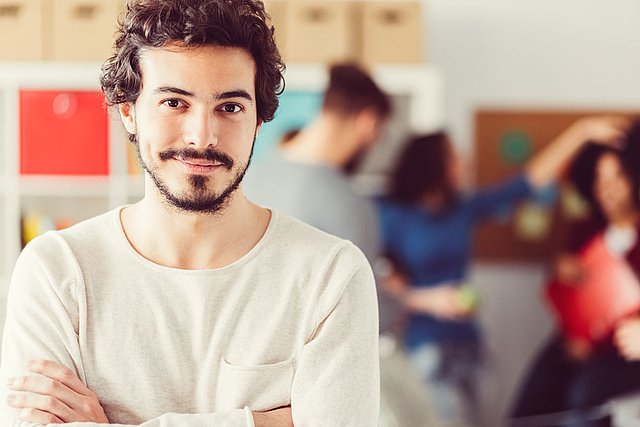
[0,236,254,427]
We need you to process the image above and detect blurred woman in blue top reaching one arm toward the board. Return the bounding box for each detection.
[379,117,628,426]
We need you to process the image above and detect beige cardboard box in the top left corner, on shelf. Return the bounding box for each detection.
[0,0,44,61]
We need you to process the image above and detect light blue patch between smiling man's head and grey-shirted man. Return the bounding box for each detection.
[253,90,322,161]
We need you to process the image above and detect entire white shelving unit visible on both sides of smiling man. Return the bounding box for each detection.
[0,62,443,297]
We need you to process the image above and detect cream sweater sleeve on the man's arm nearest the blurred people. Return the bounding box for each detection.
[291,245,380,427]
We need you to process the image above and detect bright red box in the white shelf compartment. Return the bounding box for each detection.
[19,90,109,175]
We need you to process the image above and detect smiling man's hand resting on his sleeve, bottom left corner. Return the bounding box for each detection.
[7,360,109,424]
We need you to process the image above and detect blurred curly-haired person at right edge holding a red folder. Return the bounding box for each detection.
[512,123,640,427]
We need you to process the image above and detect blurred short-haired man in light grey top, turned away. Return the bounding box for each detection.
[243,63,438,427]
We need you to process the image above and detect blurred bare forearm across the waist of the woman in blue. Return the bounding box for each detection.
[404,285,473,321]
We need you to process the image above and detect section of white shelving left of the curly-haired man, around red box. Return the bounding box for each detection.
[0,62,135,295]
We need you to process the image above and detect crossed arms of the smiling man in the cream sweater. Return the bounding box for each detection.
[0,239,379,427]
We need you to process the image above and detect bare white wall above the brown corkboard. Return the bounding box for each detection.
[423,0,640,150]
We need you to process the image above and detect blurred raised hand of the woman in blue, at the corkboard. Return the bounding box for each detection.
[569,116,632,148]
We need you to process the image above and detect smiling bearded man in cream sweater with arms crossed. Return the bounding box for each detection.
[0,0,379,427]
